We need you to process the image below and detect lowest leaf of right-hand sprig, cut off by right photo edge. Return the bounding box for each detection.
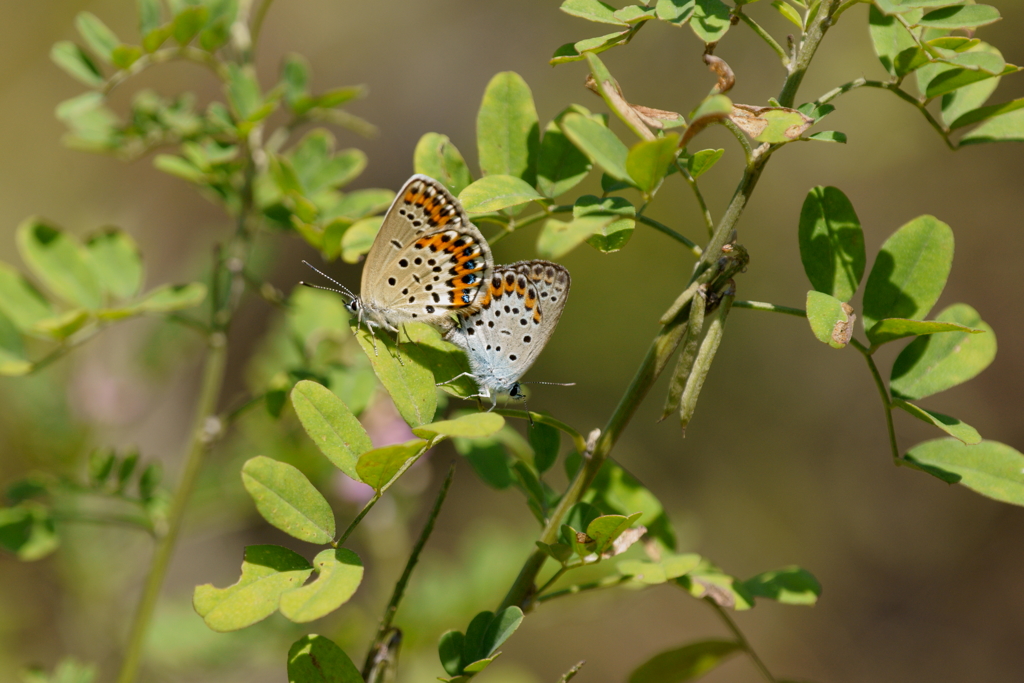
[904,438,1024,505]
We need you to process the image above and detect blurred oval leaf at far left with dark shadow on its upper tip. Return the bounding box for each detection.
[16,217,103,309]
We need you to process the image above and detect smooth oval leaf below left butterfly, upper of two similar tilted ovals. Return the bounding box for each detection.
[292,380,373,481]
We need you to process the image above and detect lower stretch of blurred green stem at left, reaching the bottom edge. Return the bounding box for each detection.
[117,333,227,683]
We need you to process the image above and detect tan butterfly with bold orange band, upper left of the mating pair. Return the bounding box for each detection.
[302,174,494,333]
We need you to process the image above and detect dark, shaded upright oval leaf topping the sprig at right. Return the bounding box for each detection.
[799,185,866,301]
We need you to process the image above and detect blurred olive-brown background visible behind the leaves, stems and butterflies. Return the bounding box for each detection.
[0,0,1024,683]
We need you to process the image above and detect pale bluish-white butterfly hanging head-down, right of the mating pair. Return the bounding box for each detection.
[444,261,570,410]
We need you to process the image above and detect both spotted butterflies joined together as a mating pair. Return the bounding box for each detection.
[303,174,569,408]
